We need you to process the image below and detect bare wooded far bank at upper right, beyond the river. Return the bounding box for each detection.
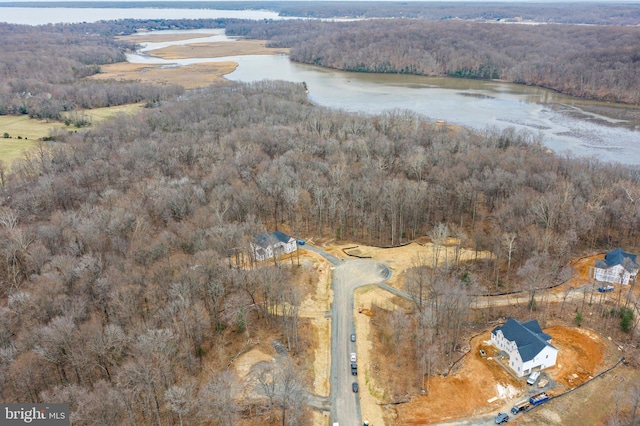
[227,19,640,104]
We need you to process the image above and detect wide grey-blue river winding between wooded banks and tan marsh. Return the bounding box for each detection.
[128,30,640,165]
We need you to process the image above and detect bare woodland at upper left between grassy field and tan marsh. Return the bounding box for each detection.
[0,24,182,120]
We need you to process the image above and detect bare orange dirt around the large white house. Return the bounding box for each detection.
[396,326,615,425]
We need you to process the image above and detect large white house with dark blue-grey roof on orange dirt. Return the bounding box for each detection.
[491,318,558,376]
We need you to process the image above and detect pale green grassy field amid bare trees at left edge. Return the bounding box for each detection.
[0,104,142,166]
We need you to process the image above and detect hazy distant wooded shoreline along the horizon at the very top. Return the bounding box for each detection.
[5,1,640,25]
